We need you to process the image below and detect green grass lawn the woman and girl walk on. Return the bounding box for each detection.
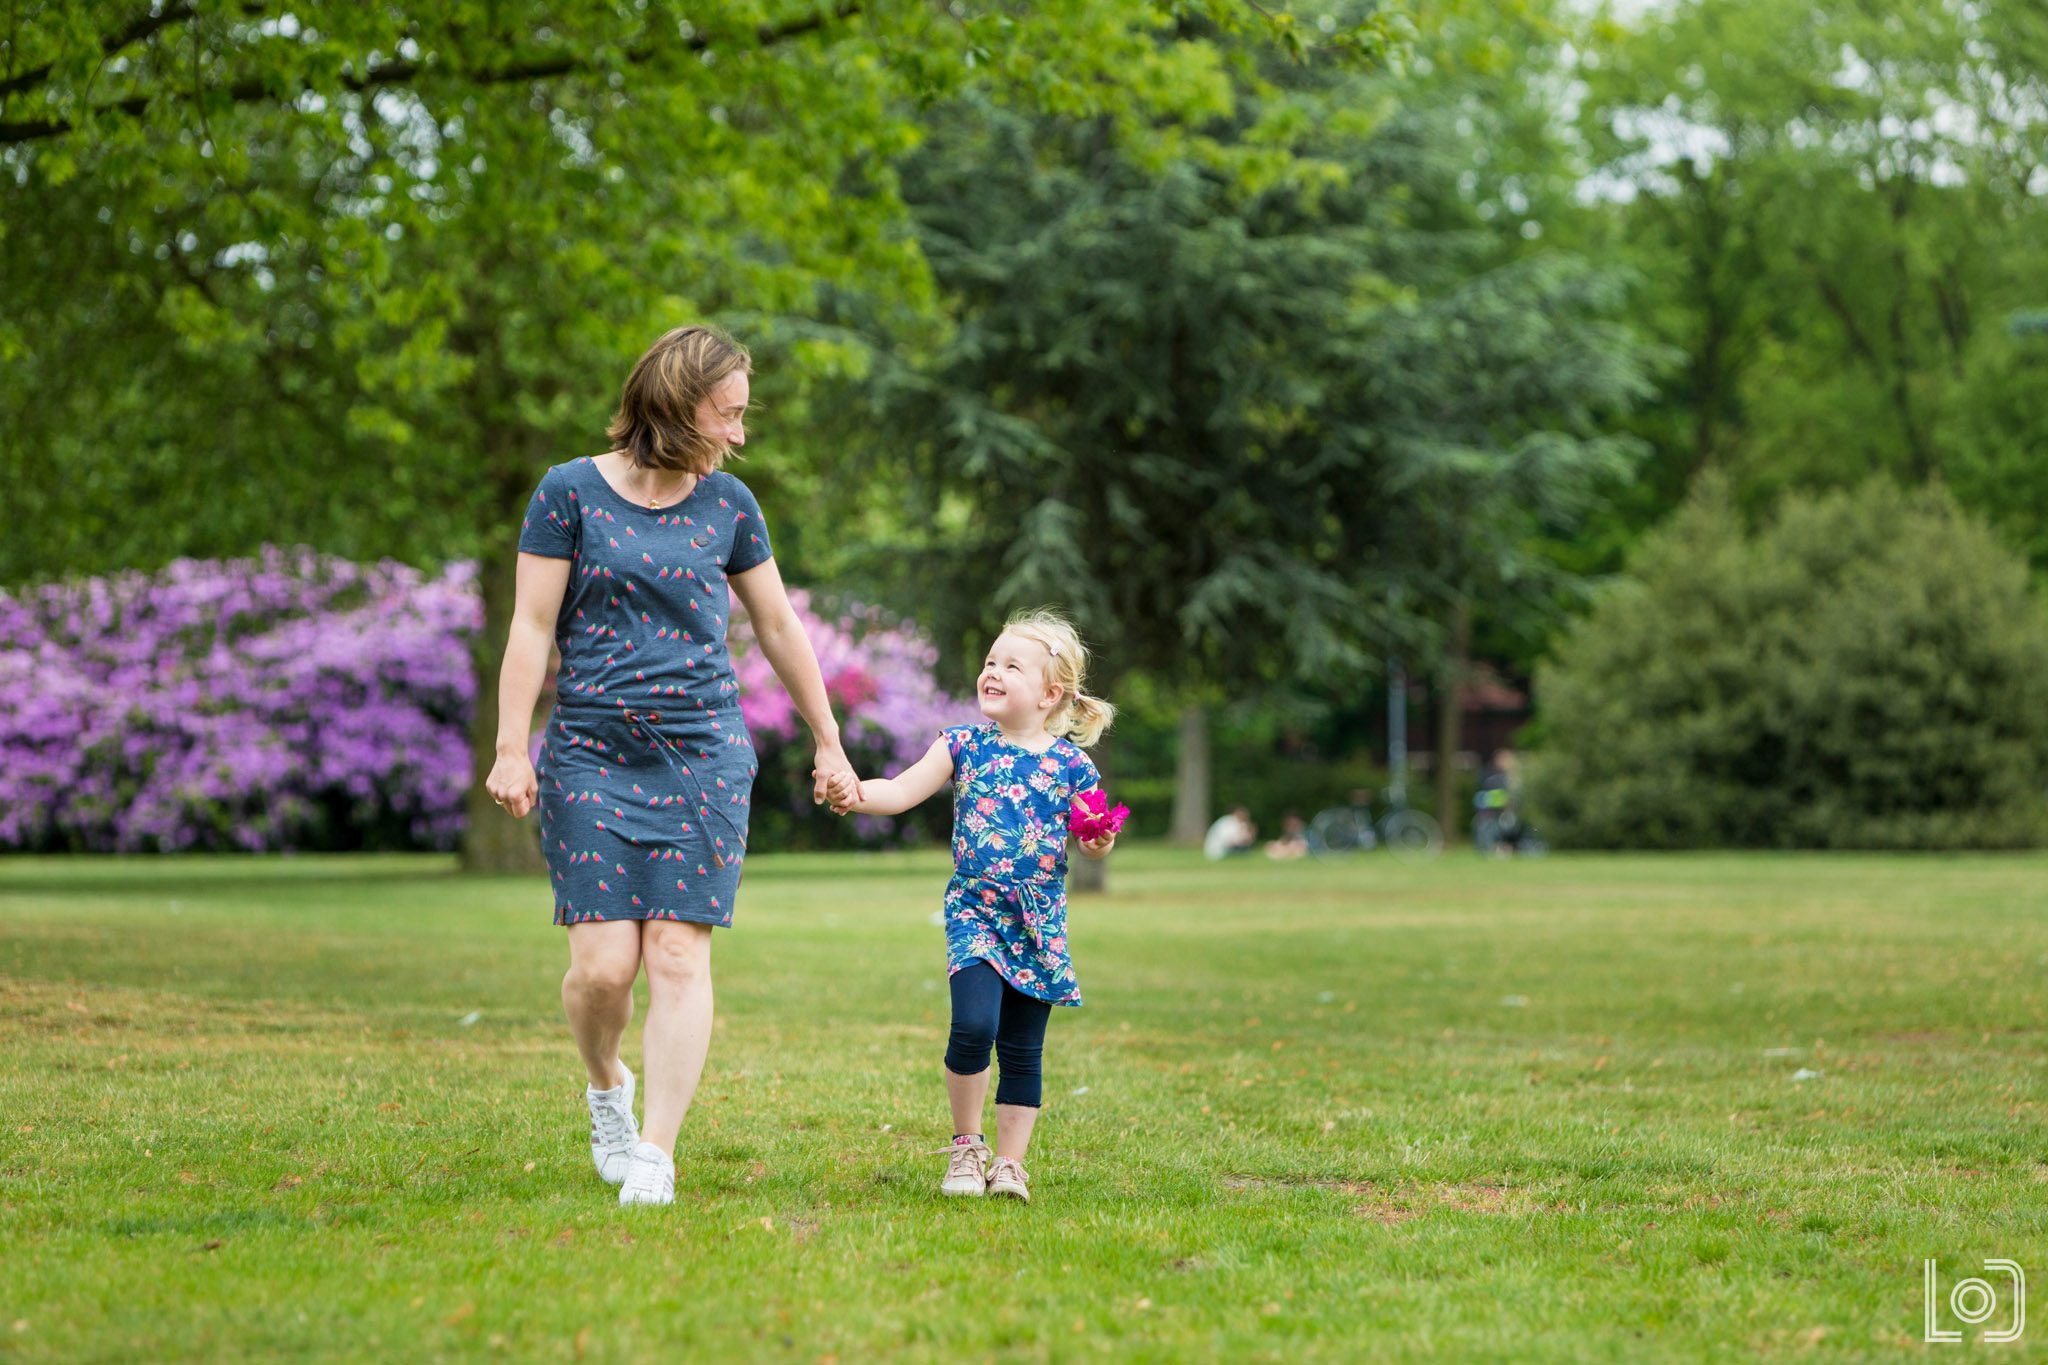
[0,847,2048,1363]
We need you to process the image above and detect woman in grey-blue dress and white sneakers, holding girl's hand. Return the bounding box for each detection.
[485,327,852,1203]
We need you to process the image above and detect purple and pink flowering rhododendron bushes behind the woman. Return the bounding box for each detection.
[0,548,975,851]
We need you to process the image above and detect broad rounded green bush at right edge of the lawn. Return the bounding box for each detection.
[1530,479,2048,849]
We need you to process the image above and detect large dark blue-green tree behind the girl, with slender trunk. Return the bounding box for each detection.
[839,7,1640,837]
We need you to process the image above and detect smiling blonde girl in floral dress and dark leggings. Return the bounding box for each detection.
[831,612,1116,1203]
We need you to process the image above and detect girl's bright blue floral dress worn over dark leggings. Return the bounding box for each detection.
[946,720,1102,1005]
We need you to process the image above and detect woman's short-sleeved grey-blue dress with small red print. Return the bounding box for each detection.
[518,458,772,925]
